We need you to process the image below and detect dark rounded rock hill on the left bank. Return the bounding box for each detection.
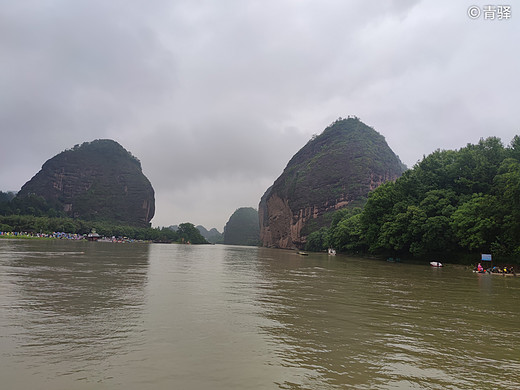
[17,140,155,227]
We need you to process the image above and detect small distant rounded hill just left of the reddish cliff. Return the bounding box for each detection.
[224,207,260,245]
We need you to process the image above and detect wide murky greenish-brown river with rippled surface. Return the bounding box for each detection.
[0,240,520,390]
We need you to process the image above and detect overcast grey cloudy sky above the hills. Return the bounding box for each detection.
[0,0,520,231]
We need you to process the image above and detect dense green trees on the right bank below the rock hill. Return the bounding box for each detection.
[306,136,520,264]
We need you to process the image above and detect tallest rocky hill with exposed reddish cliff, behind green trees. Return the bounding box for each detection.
[258,117,406,248]
